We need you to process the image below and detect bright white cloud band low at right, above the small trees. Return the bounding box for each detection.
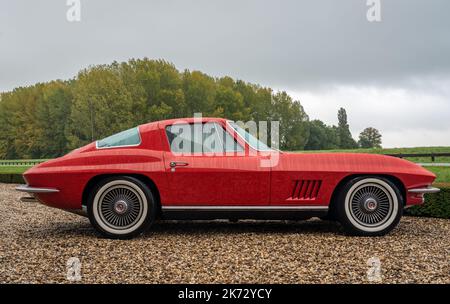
[288,78,450,147]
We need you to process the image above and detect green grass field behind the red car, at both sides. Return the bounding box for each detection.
[0,147,450,183]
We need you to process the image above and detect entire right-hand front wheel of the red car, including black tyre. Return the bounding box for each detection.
[336,177,403,236]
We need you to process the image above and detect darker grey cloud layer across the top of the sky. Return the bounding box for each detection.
[0,0,450,90]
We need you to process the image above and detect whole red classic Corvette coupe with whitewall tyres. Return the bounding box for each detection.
[17,118,439,238]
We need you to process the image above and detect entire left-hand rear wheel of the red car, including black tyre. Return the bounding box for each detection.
[88,176,156,239]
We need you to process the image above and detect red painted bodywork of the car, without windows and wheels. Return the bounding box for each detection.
[24,118,436,209]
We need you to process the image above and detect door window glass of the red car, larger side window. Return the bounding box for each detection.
[166,122,243,153]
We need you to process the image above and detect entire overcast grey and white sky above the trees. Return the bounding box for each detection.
[0,0,450,147]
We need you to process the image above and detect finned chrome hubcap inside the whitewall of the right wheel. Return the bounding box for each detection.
[350,183,393,227]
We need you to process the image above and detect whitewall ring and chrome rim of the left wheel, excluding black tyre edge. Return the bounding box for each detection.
[92,180,148,234]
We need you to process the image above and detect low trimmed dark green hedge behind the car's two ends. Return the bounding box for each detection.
[0,174,450,219]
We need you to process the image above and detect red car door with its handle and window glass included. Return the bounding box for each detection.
[164,122,270,206]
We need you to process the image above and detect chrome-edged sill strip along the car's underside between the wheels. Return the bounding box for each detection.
[162,206,328,211]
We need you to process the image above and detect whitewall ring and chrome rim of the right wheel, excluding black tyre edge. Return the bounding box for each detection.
[344,178,400,233]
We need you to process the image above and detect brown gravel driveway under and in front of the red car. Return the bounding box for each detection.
[0,184,450,284]
